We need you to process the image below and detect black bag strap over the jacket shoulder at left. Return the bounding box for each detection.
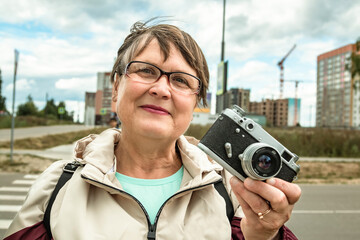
[43,162,80,239]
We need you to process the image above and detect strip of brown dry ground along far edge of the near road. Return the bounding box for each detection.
[0,154,360,184]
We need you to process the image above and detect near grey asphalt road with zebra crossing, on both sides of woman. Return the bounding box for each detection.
[0,173,360,240]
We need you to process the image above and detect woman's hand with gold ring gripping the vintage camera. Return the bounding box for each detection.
[231,177,301,239]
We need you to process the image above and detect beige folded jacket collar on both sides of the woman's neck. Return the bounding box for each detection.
[74,129,222,191]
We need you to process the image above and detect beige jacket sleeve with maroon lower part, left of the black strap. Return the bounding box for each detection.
[5,161,68,240]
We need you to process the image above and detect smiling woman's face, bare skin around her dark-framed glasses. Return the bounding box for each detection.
[113,40,197,141]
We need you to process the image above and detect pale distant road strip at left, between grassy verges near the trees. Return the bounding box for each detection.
[0,125,94,142]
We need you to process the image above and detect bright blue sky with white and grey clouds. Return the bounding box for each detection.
[0,0,360,126]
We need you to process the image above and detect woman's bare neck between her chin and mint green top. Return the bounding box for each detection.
[115,134,182,179]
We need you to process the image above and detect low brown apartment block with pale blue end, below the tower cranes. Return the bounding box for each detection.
[249,98,301,127]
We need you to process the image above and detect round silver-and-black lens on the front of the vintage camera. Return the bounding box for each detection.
[241,143,281,180]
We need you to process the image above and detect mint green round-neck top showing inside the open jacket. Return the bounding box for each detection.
[115,166,184,224]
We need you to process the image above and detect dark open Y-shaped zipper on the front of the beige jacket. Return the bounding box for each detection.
[81,175,222,240]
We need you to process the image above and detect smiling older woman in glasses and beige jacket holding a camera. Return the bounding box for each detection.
[5,20,301,240]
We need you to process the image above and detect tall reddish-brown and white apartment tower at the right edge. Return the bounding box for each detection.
[316,41,360,127]
